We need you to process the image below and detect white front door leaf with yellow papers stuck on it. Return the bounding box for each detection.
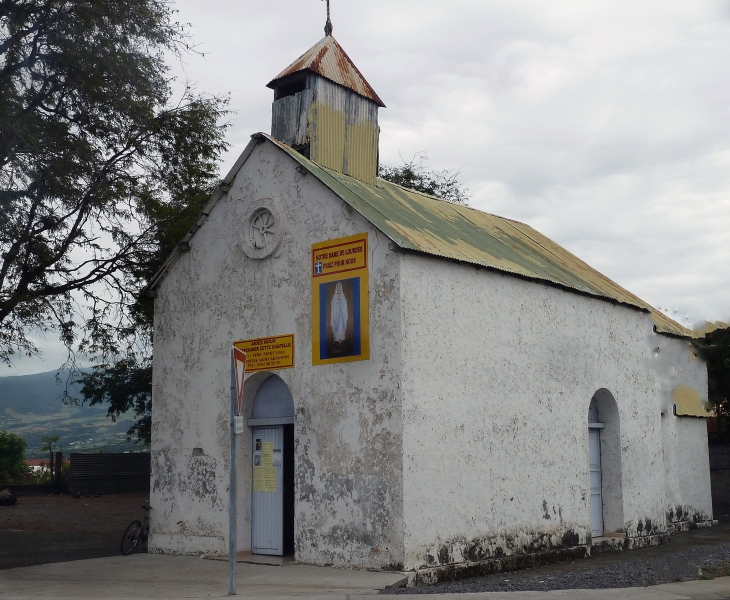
[251,426,284,556]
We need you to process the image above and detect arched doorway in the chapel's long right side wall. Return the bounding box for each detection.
[588,388,624,537]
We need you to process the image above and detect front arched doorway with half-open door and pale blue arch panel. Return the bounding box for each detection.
[248,375,294,556]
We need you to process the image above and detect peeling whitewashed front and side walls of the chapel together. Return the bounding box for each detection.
[150,137,711,569]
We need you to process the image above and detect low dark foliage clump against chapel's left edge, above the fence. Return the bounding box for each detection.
[78,356,152,444]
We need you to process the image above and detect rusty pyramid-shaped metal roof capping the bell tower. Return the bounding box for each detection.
[267,35,385,107]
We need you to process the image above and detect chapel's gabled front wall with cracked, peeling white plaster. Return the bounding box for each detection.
[145,143,403,568]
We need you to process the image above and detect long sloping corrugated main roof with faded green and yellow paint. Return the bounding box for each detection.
[266,135,693,337]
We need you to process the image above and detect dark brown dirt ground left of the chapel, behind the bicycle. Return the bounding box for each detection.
[0,492,147,569]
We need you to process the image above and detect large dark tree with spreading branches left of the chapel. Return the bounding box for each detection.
[0,0,225,364]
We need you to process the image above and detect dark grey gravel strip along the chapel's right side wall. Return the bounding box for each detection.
[384,543,730,594]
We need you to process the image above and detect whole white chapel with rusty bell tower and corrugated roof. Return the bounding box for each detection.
[146,30,713,582]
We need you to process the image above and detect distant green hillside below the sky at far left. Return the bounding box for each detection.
[0,371,142,458]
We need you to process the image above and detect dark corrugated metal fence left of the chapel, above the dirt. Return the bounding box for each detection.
[68,452,151,494]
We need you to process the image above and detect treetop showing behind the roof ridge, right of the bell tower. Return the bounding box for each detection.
[379,152,469,204]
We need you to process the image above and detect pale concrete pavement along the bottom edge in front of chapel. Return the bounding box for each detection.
[0,554,730,600]
